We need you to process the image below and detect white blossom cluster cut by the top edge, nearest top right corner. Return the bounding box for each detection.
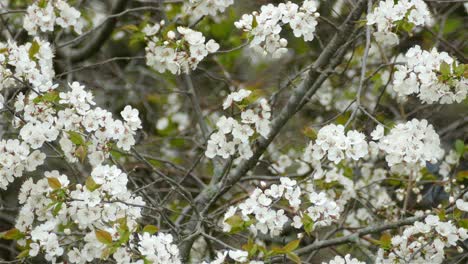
[367,0,433,46]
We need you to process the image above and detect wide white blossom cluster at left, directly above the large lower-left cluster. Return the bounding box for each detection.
[22,82,141,166]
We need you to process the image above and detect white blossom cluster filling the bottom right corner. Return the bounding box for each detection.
[376,215,468,264]
